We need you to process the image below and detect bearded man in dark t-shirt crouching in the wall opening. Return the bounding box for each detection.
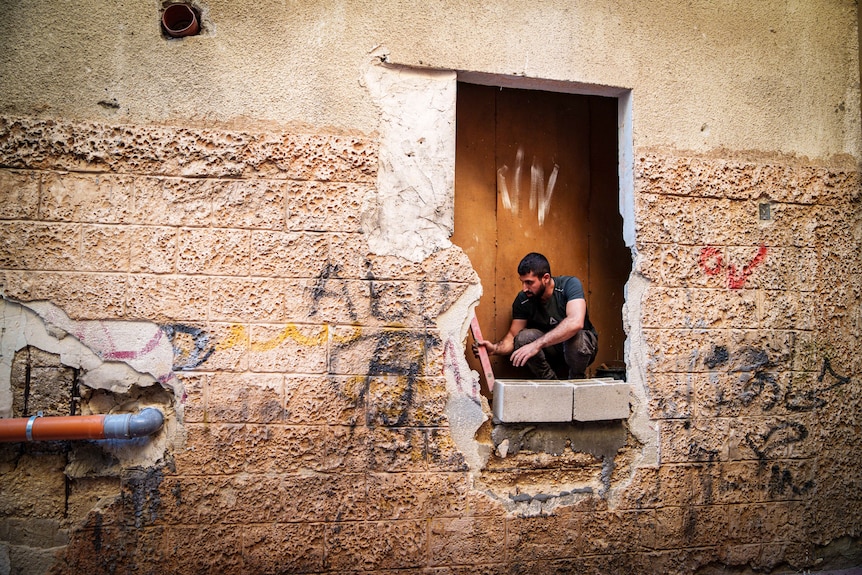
[476,252,599,379]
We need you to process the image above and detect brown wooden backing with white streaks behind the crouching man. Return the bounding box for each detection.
[452,81,632,394]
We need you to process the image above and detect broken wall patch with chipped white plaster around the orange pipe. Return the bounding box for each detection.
[0,298,182,574]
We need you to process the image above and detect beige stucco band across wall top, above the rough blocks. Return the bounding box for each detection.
[0,0,860,158]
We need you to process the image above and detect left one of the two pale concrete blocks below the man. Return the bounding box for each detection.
[492,379,573,423]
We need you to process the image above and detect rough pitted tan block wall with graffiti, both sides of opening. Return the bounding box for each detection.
[0,119,862,574]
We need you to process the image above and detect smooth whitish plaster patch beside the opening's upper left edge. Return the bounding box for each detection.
[362,54,456,261]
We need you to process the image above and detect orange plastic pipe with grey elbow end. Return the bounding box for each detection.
[0,407,164,442]
